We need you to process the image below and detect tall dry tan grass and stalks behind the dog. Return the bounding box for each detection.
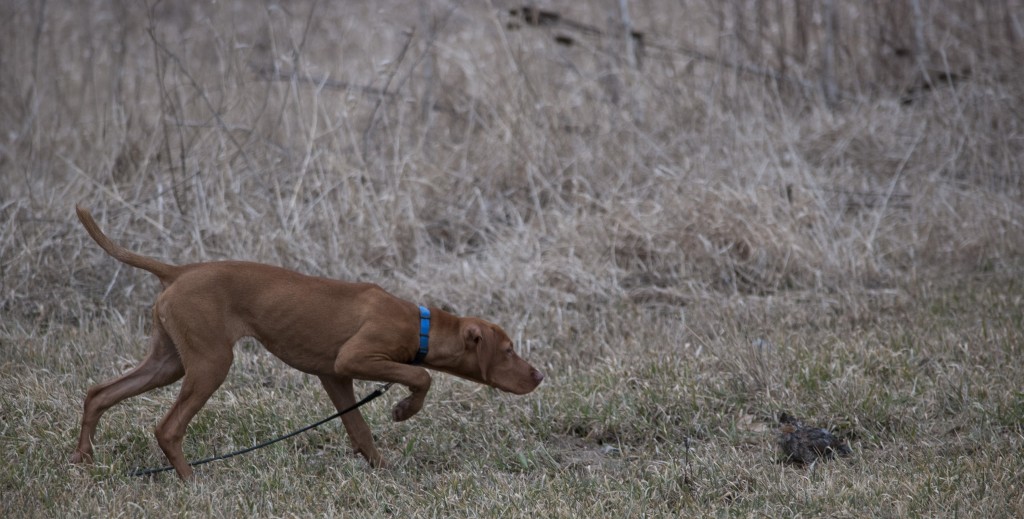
[2,2,1022,321]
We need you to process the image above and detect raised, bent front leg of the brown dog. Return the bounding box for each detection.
[334,345,431,422]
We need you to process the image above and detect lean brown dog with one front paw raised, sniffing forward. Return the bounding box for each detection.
[72,207,544,479]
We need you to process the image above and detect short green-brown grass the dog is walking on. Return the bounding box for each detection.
[2,279,1024,516]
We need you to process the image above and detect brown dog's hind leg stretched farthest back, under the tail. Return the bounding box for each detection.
[71,319,184,463]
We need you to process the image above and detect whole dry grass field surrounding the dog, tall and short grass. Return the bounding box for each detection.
[0,0,1024,518]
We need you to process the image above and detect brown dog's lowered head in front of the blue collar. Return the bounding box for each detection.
[458,317,544,395]
